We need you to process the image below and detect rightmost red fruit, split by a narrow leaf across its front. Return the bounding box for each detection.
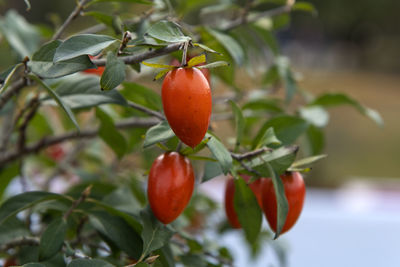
[262,172,306,234]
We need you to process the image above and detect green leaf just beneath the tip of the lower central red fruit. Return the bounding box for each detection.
[140,208,174,258]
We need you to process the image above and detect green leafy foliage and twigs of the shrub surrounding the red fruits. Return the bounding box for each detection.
[0,0,381,266]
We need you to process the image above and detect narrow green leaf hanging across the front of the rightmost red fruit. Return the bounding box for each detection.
[267,163,289,239]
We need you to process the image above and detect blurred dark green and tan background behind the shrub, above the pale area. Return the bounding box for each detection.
[0,0,400,187]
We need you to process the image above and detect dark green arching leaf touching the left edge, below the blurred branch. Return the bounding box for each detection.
[0,191,72,224]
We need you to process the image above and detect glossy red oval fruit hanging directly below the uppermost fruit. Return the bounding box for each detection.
[147,152,194,224]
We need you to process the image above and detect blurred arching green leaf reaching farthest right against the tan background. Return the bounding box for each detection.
[308,93,383,127]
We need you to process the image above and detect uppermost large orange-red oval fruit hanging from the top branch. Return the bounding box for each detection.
[161,68,212,148]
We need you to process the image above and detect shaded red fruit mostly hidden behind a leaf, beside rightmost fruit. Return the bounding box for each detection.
[224,175,264,229]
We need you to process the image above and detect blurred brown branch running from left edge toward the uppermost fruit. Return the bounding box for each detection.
[0,118,160,167]
